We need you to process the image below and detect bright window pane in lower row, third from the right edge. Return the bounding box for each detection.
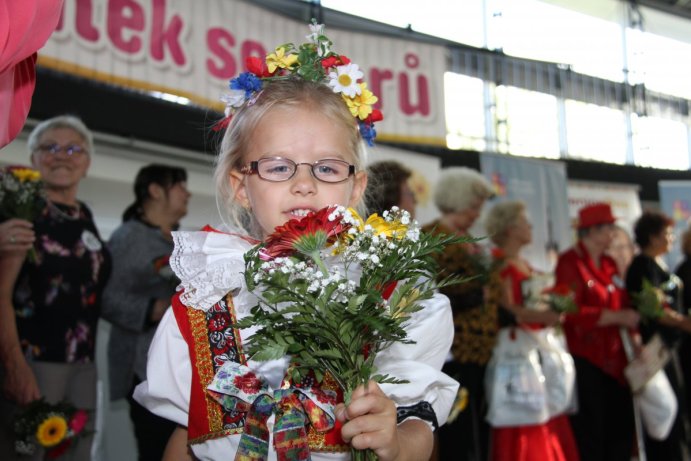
[496,86,559,158]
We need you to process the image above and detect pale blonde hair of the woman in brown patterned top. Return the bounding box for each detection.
[434,167,494,213]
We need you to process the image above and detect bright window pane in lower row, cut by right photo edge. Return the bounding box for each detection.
[632,115,689,170]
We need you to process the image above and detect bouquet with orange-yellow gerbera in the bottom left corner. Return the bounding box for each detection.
[14,399,88,459]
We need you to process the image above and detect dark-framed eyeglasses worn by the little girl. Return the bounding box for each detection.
[240,157,355,183]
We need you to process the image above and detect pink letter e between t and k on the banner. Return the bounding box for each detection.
[107,0,146,54]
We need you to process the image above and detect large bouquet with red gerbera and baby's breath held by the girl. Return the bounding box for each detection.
[238,207,466,459]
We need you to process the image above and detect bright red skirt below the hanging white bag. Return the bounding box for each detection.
[490,415,580,461]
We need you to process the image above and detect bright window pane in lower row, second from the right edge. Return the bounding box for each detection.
[565,100,626,164]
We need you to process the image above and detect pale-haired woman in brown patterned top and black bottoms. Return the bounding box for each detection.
[424,167,501,460]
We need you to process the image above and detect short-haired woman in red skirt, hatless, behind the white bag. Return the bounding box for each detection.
[485,200,579,461]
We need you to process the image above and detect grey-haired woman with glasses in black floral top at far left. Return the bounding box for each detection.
[0,116,110,460]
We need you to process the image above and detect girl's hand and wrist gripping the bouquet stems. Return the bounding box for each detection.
[336,381,433,461]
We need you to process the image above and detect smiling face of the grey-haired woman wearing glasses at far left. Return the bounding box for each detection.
[31,128,91,189]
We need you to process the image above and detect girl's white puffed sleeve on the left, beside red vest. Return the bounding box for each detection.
[134,309,192,426]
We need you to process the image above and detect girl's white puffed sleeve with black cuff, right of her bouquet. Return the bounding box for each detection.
[375,293,458,428]
